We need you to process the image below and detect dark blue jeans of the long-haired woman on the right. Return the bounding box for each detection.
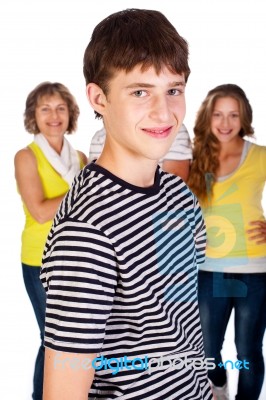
[198,271,266,400]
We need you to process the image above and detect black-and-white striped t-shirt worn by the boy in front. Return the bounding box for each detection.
[41,163,212,400]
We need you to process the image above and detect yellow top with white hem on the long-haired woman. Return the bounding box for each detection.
[200,144,266,273]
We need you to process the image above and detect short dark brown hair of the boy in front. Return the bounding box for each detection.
[83,9,190,118]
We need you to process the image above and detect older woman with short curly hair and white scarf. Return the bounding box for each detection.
[15,82,87,400]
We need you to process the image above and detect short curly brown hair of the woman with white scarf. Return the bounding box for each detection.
[24,82,80,134]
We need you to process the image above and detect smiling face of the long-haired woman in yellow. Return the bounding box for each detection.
[211,97,241,143]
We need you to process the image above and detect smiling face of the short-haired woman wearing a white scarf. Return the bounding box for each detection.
[35,94,69,139]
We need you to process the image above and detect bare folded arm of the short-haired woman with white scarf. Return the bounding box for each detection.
[15,149,64,224]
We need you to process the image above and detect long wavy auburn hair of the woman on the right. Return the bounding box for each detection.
[188,84,254,205]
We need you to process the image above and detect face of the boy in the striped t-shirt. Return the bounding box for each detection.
[94,66,185,162]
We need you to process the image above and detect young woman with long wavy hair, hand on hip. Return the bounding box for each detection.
[188,84,266,400]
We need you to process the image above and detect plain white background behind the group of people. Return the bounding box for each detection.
[0,0,266,400]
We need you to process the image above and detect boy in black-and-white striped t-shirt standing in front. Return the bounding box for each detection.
[41,9,212,400]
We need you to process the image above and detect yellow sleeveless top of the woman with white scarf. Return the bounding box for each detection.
[21,142,84,267]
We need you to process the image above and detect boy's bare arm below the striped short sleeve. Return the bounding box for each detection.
[43,347,96,400]
